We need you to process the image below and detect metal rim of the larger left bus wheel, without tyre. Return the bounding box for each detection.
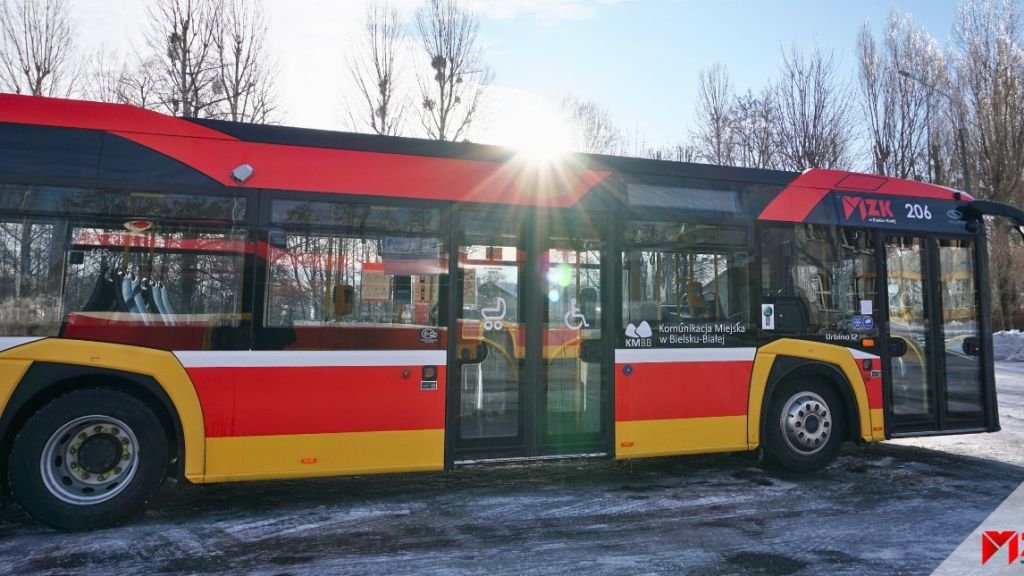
[39,415,138,505]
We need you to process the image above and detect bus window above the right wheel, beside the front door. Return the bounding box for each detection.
[761,224,878,336]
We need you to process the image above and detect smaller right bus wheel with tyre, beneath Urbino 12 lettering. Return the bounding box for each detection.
[765,380,846,472]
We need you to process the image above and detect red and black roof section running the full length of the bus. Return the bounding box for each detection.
[0,94,973,221]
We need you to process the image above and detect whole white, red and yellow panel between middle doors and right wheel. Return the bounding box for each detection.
[615,348,755,458]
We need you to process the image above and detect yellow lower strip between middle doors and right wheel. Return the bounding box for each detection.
[615,416,746,458]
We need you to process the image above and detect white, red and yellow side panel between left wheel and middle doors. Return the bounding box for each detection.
[178,351,445,482]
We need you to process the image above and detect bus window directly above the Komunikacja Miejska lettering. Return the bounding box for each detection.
[623,218,750,336]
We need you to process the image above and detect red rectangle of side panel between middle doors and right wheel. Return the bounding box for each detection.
[615,361,754,421]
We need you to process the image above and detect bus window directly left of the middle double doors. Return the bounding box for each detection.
[262,200,447,349]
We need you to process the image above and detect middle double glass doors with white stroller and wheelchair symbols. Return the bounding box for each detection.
[449,208,610,461]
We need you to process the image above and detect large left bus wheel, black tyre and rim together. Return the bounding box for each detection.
[8,388,168,530]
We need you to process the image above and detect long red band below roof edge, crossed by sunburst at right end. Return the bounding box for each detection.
[116,131,610,207]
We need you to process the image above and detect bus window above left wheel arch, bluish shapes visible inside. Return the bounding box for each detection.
[62,219,250,349]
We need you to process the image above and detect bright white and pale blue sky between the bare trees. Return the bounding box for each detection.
[73,0,955,150]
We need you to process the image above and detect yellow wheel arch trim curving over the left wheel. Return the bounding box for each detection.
[0,338,206,483]
